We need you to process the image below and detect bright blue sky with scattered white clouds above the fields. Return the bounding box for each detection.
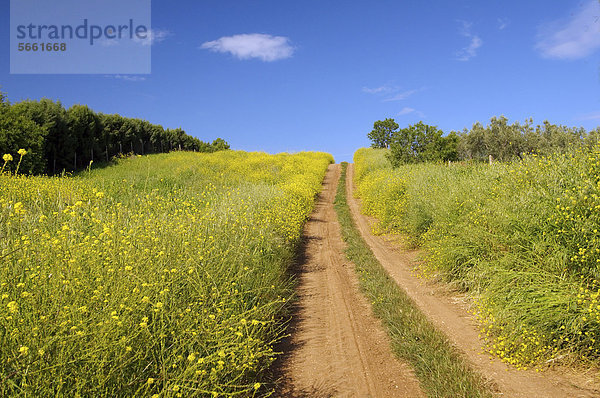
[0,0,600,161]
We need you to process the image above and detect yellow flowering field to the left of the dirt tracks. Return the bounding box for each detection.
[0,151,333,397]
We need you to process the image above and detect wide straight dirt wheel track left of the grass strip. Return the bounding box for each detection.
[276,165,423,398]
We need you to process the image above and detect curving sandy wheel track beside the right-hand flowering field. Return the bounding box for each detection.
[346,165,600,398]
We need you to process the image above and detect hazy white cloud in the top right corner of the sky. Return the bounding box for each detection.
[535,0,600,59]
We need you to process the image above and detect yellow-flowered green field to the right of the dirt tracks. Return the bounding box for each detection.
[355,147,600,370]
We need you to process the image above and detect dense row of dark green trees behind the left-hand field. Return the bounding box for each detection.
[0,92,229,174]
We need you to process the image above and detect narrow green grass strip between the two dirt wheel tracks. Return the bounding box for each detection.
[335,163,492,398]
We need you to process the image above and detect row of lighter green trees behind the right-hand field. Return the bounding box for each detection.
[368,116,600,166]
